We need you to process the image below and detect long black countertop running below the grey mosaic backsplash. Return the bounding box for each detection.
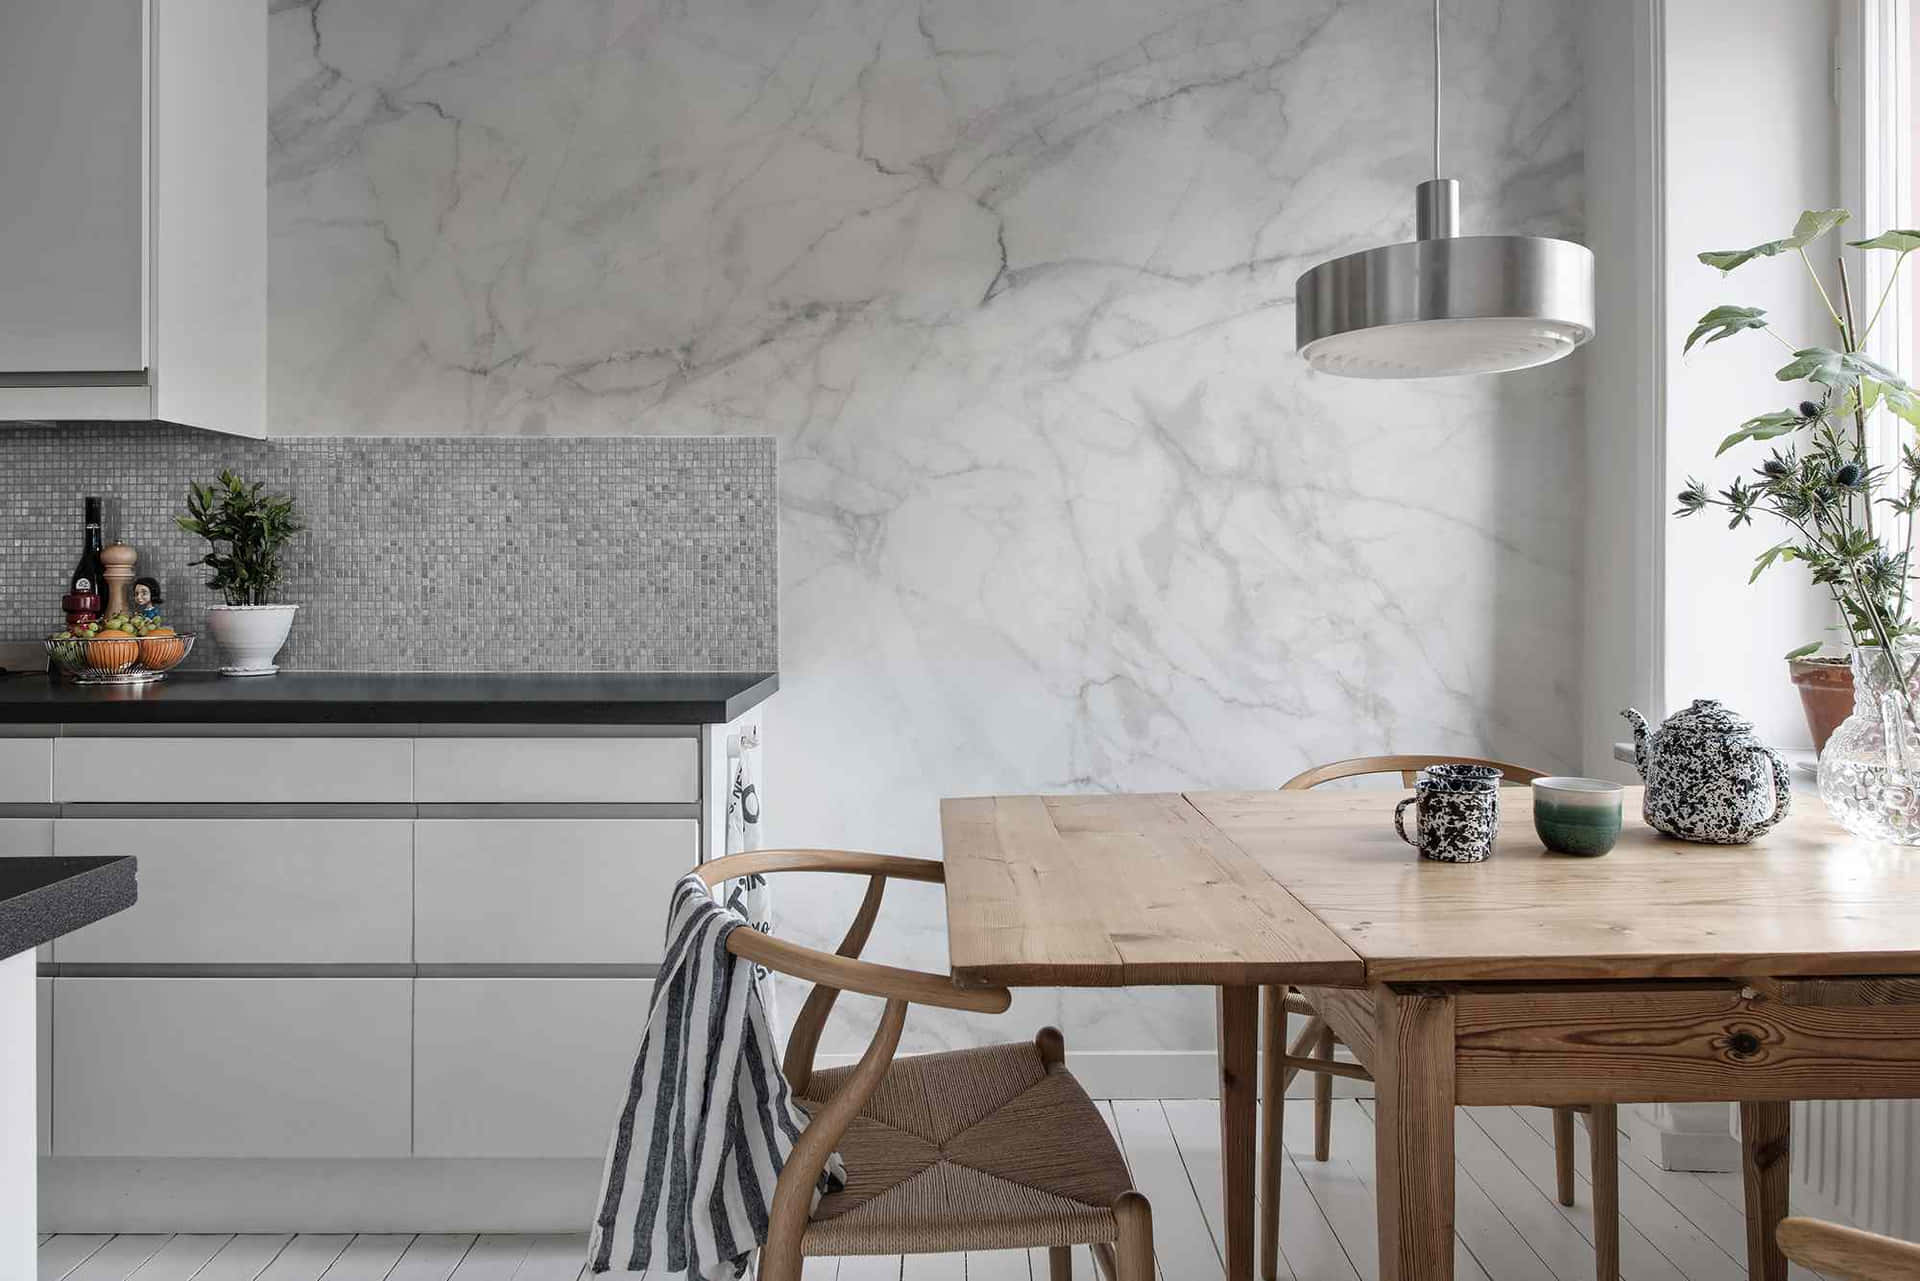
[0,672,780,726]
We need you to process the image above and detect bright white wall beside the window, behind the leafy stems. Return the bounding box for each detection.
[1661,0,1843,747]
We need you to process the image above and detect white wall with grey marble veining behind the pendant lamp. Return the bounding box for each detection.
[269,0,1584,1051]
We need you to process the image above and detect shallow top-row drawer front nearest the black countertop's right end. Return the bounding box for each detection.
[413,737,701,805]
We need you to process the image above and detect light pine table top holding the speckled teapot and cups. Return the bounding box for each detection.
[941,787,1920,987]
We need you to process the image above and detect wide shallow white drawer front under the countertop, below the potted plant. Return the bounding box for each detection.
[54,737,413,805]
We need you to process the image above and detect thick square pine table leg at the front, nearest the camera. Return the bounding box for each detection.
[1373,987,1453,1281]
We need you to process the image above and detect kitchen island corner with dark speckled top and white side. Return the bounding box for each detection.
[0,845,138,1277]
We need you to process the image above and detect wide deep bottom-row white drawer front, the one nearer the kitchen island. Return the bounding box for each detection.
[54,978,411,1156]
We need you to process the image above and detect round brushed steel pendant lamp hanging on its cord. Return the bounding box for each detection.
[1294,0,1594,378]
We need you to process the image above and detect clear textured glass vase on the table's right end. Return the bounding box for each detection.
[1820,640,1920,845]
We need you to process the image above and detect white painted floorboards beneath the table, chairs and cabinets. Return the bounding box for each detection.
[38,1099,1818,1281]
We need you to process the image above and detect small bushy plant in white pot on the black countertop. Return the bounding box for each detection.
[175,469,301,676]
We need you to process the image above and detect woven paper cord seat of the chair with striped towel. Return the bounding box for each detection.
[801,1041,1131,1254]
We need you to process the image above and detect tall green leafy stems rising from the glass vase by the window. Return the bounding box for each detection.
[1674,209,1920,714]
